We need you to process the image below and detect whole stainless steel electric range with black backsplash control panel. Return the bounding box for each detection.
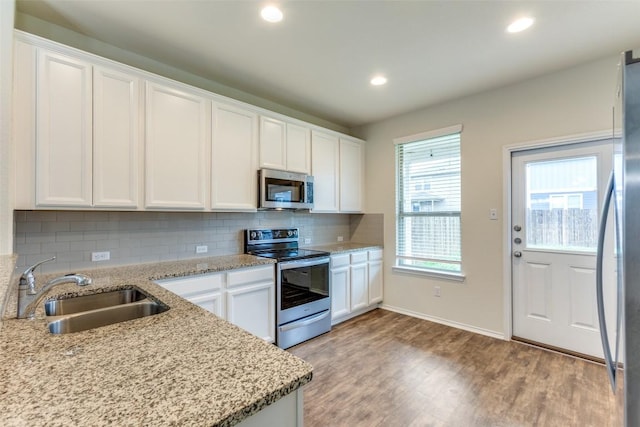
[245,228,331,348]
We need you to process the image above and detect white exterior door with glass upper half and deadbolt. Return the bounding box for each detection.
[511,140,615,358]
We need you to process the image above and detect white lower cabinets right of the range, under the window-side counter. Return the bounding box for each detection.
[331,249,383,325]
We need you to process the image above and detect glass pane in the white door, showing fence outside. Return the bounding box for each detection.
[526,156,598,252]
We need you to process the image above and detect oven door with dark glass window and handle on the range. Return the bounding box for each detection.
[276,257,331,325]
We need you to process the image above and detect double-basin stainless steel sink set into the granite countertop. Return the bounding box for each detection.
[45,287,169,334]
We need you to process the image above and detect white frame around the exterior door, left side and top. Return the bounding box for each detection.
[502,129,613,341]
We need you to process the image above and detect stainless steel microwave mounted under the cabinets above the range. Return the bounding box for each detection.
[258,169,313,209]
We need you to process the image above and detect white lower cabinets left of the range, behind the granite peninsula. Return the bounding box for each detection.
[156,265,275,342]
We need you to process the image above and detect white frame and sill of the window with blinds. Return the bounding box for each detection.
[392,124,465,281]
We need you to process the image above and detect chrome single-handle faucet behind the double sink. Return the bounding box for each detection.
[18,257,91,319]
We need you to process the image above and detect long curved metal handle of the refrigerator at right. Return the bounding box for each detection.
[596,171,616,393]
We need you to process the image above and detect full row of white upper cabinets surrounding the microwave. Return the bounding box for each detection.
[12,30,364,212]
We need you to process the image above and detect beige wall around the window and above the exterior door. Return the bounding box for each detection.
[354,55,617,335]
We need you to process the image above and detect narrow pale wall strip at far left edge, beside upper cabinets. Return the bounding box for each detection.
[0,0,15,255]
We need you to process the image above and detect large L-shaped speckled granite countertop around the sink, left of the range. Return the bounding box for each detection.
[0,255,312,426]
